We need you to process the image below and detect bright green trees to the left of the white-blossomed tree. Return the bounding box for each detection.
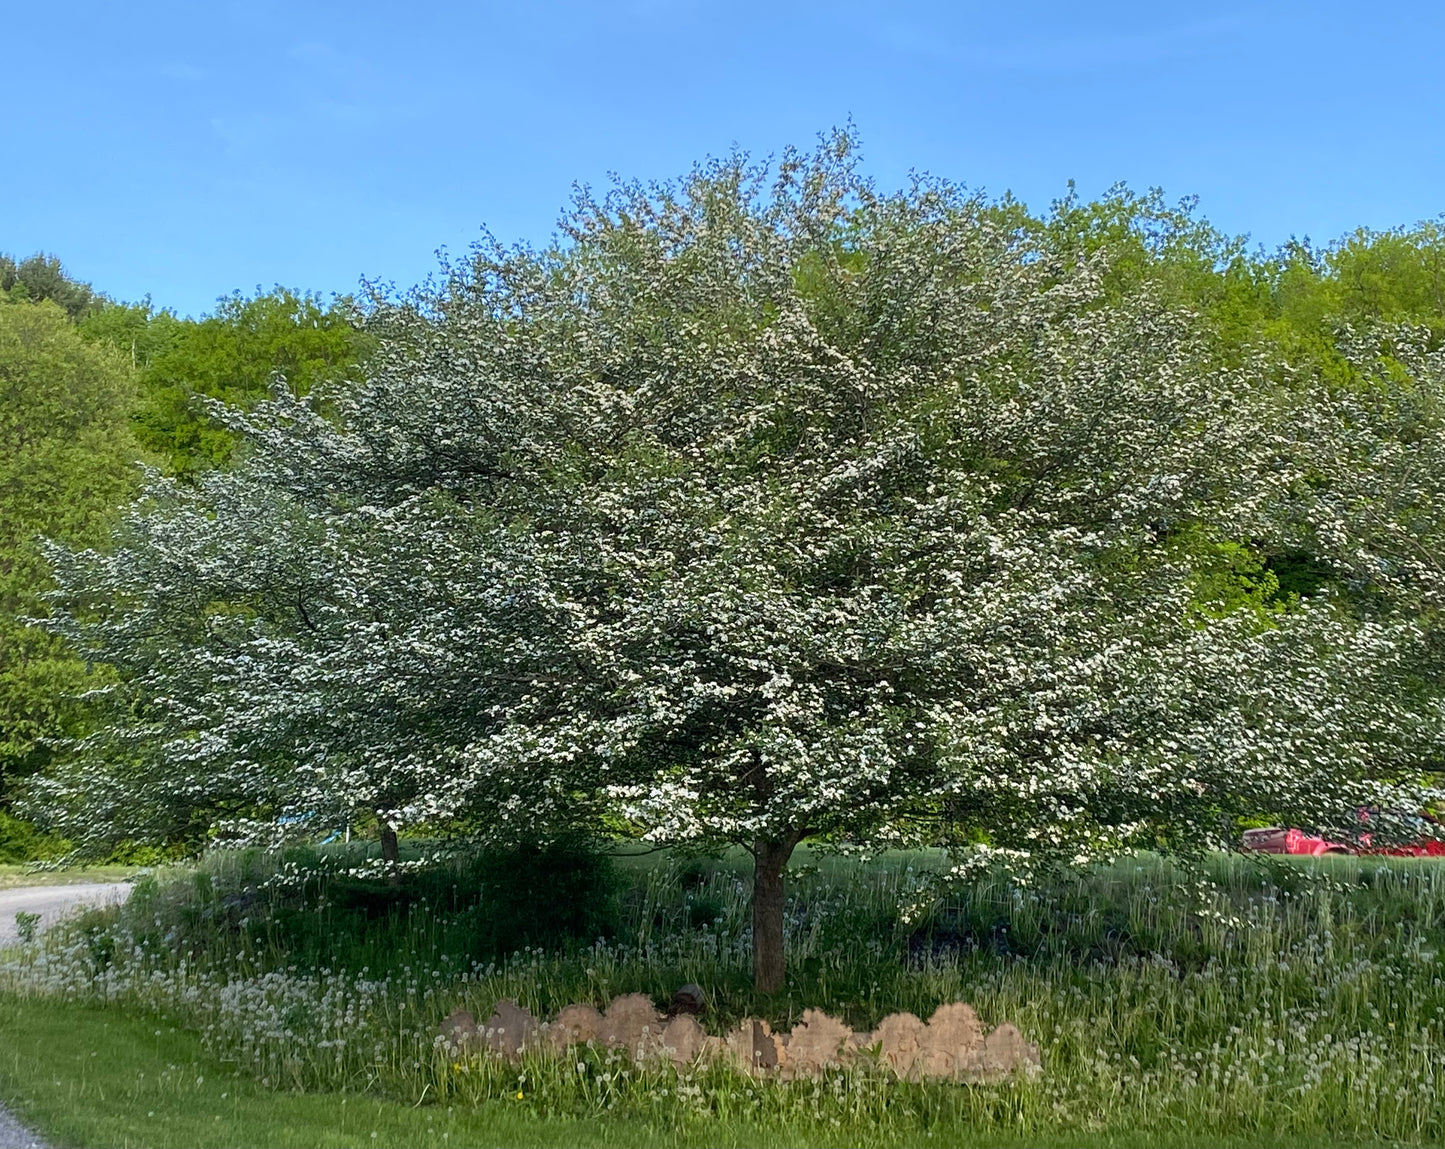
[0,254,367,861]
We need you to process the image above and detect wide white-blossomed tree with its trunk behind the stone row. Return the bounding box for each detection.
[46,137,1439,990]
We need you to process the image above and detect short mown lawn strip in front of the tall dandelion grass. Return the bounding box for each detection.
[0,999,1374,1149]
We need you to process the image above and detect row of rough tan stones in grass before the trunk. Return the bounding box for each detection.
[438,993,1040,1083]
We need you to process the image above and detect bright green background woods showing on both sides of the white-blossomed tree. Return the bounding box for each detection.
[0,195,1445,860]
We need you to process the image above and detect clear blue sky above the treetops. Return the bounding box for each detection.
[0,0,1445,314]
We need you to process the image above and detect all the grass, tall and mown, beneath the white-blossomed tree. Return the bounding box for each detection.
[0,851,1445,1145]
